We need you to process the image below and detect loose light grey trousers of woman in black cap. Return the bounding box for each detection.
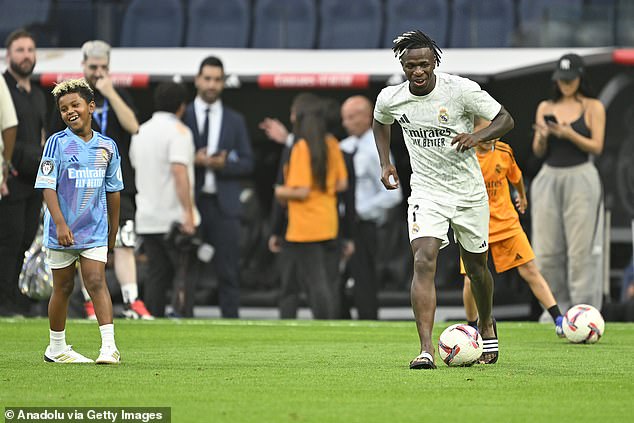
[531,162,604,314]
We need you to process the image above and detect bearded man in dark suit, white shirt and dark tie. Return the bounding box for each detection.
[183,56,253,318]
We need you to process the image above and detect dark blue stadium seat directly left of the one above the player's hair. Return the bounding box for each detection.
[318,0,382,49]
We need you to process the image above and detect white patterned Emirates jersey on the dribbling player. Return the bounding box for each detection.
[374,72,502,206]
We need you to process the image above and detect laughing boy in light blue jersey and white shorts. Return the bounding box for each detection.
[35,79,123,364]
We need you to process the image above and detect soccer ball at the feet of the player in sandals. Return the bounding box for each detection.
[438,324,482,366]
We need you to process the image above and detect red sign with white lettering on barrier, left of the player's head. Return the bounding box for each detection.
[258,73,370,88]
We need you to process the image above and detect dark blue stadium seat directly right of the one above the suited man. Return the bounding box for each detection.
[251,0,317,48]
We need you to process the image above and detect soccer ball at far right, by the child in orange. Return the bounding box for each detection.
[562,304,605,344]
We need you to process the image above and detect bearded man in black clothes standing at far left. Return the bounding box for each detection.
[0,29,46,315]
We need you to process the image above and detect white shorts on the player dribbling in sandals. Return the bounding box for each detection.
[407,197,489,253]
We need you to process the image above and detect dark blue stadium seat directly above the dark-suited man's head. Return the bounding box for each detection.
[185,0,251,48]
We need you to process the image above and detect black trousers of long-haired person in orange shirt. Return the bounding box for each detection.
[279,240,341,319]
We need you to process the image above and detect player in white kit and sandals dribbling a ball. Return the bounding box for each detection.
[373,31,514,369]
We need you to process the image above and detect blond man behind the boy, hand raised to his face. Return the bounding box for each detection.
[50,40,153,320]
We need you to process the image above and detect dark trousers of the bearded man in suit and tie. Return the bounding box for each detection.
[197,194,240,318]
